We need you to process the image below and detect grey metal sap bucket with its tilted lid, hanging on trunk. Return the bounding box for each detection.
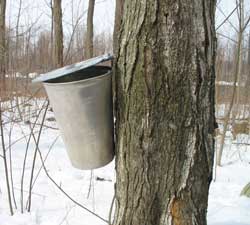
[33,55,114,169]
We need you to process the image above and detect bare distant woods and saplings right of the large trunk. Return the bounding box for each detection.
[216,0,250,166]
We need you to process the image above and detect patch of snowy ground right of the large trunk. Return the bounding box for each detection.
[208,135,250,225]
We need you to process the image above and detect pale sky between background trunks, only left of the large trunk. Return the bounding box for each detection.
[6,0,115,33]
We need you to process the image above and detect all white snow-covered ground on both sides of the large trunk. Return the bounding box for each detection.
[0,100,250,225]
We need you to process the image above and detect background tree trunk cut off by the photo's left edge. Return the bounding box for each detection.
[0,0,6,97]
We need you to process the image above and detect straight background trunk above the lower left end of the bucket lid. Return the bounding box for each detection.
[53,0,63,67]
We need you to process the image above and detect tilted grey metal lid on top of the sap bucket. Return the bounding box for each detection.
[32,54,113,83]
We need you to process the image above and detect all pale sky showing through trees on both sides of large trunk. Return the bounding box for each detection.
[6,0,250,44]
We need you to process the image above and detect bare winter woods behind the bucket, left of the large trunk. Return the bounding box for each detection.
[0,0,113,98]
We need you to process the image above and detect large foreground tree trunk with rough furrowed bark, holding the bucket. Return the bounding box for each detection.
[114,0,216,225]
